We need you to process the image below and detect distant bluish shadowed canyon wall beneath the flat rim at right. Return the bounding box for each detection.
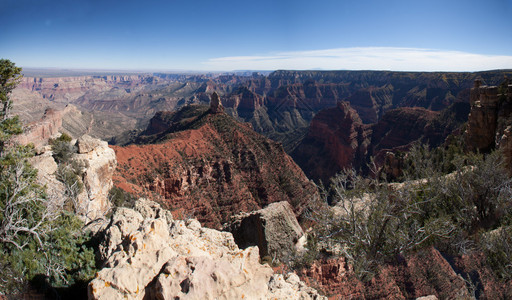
[219,71,510,152]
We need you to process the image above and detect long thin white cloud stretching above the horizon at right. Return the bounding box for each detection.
[203,47,512,71]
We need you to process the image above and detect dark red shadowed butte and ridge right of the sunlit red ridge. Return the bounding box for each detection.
[292,102,467,182]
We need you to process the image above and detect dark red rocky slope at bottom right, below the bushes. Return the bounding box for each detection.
[301,248,472,299]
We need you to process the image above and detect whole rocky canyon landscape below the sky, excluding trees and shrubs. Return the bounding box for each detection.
[9,71,512,299]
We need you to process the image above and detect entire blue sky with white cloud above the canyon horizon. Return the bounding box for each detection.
[0,0,512,71]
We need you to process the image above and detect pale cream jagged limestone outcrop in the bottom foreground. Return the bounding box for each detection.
[88,200,322,299]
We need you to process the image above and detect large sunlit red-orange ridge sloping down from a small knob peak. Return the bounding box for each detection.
[114,106,316,228]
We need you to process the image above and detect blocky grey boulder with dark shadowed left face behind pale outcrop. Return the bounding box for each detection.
[224,202,305,260]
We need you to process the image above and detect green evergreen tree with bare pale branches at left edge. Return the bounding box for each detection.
[0,59,95,297]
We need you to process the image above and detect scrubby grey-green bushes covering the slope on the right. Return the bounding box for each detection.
[295,143,512,282]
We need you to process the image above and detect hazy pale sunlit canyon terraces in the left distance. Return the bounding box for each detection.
[13,75,210,139]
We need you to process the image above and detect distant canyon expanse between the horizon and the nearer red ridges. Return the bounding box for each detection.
[13,71,512,153]
